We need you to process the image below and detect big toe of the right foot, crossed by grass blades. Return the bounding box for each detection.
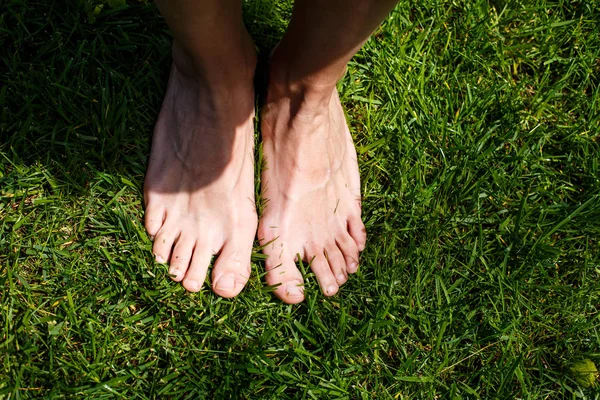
[265,252,304,304]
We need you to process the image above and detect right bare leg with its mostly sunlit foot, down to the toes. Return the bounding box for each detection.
[258,0,396,303]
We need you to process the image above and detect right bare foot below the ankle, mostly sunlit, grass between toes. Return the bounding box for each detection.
[258,83,366,303]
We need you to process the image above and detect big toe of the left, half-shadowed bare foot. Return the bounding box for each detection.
[212,238,252,298]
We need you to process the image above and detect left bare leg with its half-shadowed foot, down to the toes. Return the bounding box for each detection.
[144,0,257,297]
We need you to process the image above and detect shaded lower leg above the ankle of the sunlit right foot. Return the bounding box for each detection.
[271,0,397,90]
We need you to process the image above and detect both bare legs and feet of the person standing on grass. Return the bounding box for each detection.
[144,0,395,303]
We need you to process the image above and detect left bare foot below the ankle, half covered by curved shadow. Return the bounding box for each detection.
[144,45,257,297]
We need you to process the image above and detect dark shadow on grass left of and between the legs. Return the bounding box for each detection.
[0,0,291,195]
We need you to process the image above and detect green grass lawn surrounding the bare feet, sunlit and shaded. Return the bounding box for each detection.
[0,0,600,399]
